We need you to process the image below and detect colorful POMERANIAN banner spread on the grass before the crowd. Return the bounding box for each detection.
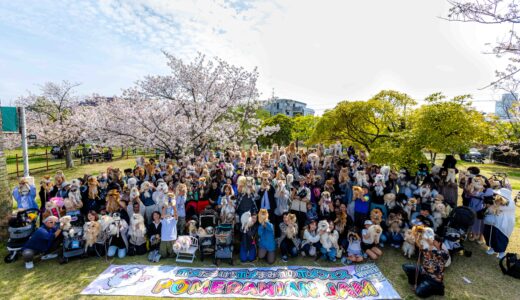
[81,264,400,299]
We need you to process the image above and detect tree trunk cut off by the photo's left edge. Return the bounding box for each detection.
[0,115,13,241]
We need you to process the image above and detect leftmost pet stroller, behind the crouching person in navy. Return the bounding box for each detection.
[4,208,39,263]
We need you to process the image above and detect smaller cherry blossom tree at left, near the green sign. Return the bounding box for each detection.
[17,81,89,168]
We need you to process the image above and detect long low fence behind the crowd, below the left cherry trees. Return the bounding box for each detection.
[6,148,161,177]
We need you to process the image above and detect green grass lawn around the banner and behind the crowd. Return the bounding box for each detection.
[0,159,520,299]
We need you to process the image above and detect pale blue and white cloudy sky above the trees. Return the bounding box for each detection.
[0,0,503,112]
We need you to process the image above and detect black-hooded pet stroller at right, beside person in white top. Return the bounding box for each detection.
[444,206,476,257]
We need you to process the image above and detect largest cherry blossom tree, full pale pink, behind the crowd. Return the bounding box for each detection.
[90,52,276,157]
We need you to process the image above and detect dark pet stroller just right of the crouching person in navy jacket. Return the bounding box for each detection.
[63,210,85,263]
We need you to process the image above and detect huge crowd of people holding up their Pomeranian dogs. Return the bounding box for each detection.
[13,142,515,296]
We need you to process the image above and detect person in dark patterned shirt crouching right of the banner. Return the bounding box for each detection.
[402,236,449,298]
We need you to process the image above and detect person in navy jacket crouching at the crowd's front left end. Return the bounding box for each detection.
[22,216,62,269]
